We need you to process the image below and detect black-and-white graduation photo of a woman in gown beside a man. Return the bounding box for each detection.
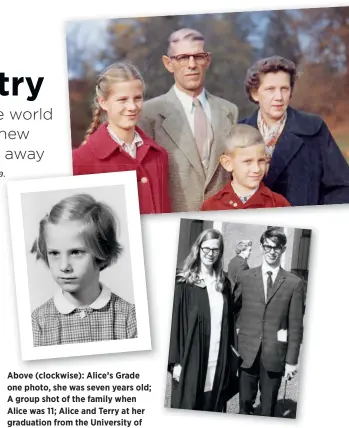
[165,219,311,418]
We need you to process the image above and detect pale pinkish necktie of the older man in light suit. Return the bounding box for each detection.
[193,98,213,168]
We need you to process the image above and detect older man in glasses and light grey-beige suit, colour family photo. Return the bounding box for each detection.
[139,28,238,212]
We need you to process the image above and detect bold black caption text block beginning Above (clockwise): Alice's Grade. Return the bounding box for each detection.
[6,372,152,428]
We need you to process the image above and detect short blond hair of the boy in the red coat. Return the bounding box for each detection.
[224,123,265,154]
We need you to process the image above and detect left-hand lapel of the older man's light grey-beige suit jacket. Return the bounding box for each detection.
[162,88,205,177]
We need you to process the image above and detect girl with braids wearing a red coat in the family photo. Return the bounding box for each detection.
[73,63,171,214]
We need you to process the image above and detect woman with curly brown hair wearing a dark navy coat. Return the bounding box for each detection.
[241,56,349,206]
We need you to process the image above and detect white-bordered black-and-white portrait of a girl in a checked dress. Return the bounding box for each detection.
[10,172,149,359]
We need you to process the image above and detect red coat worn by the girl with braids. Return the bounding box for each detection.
[73,123,171,214]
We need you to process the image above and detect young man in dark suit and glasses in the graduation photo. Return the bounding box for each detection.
[234,228,304,416]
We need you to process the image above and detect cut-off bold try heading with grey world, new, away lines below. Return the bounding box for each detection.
[0,72,52,178]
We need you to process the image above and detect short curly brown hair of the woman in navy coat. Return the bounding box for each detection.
[245,56,297,104]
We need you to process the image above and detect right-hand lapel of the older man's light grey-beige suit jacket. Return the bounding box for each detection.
[205,91,232,185]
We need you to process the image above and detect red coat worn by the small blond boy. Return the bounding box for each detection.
[200,182,290,211]
